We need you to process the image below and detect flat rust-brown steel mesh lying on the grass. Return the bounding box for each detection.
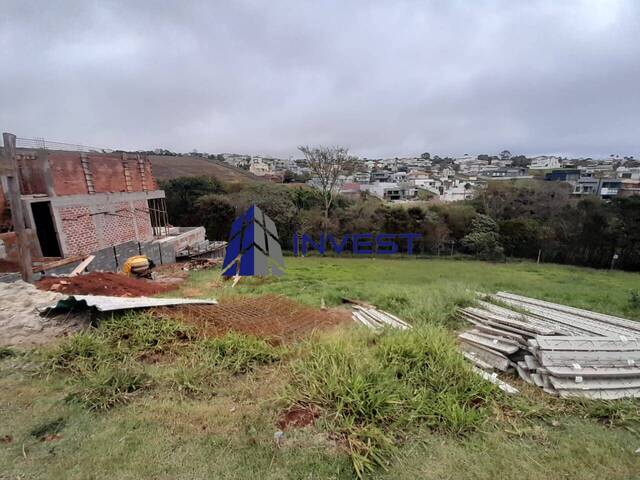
[154,295,352,343]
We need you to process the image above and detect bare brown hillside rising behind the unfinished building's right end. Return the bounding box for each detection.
[149,155,266,183]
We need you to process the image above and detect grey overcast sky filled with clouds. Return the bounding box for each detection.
[0,0,640,158]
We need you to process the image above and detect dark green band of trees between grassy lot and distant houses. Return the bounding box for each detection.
[161,177,640,271]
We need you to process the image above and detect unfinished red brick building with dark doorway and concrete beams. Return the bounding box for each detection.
[0,149,167,257]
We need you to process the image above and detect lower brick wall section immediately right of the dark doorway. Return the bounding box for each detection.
[58,206,100,256]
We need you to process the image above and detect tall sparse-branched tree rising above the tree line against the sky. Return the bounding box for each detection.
[298,146,355,230]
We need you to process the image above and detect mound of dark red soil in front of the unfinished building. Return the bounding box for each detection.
[36,272,176,297]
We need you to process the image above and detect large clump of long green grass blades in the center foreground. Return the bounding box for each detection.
[288,326,499,477]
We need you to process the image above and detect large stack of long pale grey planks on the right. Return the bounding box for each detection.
[459,292,640,400]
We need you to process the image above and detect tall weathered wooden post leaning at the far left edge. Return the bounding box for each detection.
[0,133,33,283]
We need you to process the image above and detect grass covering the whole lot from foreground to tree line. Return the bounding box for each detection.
[0,257,640,480]
